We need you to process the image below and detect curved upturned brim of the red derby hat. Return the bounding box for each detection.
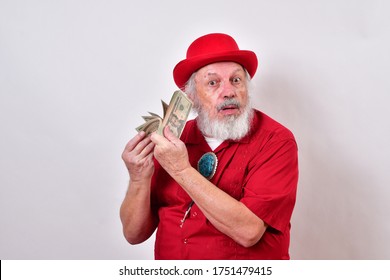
[173,50,258,89]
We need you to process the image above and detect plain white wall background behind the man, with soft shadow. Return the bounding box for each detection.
[0,0,390,259]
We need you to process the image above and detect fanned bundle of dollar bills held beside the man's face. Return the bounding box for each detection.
[136,90,192,137]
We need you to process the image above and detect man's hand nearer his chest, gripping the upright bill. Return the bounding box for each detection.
[151,126,191,177]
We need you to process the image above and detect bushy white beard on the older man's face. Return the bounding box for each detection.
[194,98,253,140]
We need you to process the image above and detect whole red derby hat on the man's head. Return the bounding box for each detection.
[173,33,257,89]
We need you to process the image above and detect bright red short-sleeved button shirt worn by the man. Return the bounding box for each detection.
[152,111,298,259]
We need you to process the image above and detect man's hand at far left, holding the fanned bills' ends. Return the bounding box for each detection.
[122,131,154,182]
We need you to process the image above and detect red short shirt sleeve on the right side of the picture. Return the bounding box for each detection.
[241,138,298,231]
